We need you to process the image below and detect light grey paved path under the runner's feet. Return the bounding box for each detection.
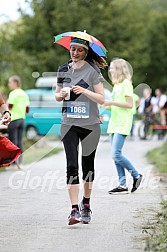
[0,138,166,252]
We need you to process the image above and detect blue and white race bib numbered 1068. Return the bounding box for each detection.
[67,101,89,118]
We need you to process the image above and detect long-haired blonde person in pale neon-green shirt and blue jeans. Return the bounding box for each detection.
[105,59,142,194]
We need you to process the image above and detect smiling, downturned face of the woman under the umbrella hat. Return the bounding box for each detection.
[70,45,86,62]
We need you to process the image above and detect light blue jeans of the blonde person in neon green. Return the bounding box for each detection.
[111,133,139,186]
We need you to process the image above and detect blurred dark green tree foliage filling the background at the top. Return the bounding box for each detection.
[0,0,167,93]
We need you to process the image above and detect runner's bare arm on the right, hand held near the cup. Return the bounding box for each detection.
[72,82,104,104]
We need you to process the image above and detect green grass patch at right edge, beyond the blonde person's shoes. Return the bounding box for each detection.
[146,142,167,173]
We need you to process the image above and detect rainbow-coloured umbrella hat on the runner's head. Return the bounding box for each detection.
[54,31,107,57]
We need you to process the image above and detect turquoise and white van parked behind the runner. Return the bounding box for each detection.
[25,77,111,139]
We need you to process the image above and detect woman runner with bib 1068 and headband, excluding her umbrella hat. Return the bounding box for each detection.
[56,38,107,225]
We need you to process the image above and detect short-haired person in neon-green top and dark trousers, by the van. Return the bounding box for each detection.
[8,76,30,164]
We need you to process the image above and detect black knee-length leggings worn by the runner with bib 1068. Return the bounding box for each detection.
[61,124,100,184]
